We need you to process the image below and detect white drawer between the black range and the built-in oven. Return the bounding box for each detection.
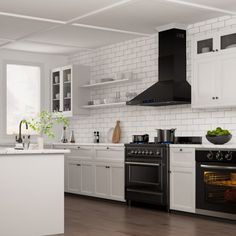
[170,148,195,168]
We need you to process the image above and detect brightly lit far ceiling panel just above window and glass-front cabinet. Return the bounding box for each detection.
[3,41,82,55]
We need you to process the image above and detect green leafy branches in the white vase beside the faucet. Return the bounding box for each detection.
[27,111,69,138]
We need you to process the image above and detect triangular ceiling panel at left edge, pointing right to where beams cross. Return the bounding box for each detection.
[0,16,55,39]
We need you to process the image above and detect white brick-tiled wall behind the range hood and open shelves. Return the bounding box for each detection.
[69,16,236,142]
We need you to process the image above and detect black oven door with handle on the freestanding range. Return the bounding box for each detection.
[125,162,163,193]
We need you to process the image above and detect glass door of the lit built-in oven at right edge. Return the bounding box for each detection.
[196,162,236,214]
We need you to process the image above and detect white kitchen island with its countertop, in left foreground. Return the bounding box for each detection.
[0,148,70,236]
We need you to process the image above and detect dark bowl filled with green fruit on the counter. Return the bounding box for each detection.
[206,127,232,145]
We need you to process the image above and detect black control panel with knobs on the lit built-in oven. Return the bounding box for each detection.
[196,149,236,163]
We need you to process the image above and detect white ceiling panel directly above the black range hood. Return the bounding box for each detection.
[77,0,223,33]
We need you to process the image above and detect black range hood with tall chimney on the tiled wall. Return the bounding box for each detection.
[126,29,191,106]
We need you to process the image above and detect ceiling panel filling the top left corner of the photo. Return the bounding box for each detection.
[0,0,125,21]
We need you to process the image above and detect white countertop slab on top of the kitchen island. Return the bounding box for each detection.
[0,148,70,155]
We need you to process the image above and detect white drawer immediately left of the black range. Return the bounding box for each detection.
[94,146,124,160]
